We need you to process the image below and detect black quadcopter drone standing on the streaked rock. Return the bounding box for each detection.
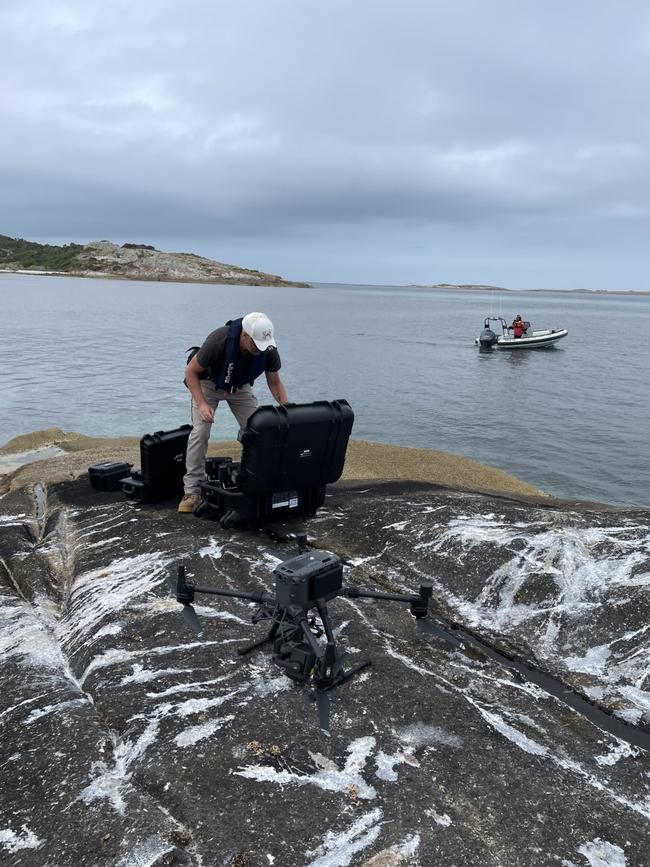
[175,536,433,734]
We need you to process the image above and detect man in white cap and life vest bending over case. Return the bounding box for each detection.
[178,312,289,512]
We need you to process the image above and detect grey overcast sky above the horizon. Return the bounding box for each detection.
[0,0,650,290]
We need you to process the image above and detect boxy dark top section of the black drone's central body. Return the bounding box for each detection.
[273,551,343,609]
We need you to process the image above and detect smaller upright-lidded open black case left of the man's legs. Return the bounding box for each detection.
[122,424,192,502]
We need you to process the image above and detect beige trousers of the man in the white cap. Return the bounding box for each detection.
[183,379,257,494]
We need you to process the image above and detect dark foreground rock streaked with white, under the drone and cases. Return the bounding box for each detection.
[0,429,650,867]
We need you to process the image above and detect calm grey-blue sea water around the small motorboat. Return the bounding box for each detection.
[0,274,650,506]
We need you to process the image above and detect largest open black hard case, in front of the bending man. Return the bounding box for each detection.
[195,400,354,529]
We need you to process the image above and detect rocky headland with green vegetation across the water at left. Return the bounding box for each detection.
[0,235,310,287]
